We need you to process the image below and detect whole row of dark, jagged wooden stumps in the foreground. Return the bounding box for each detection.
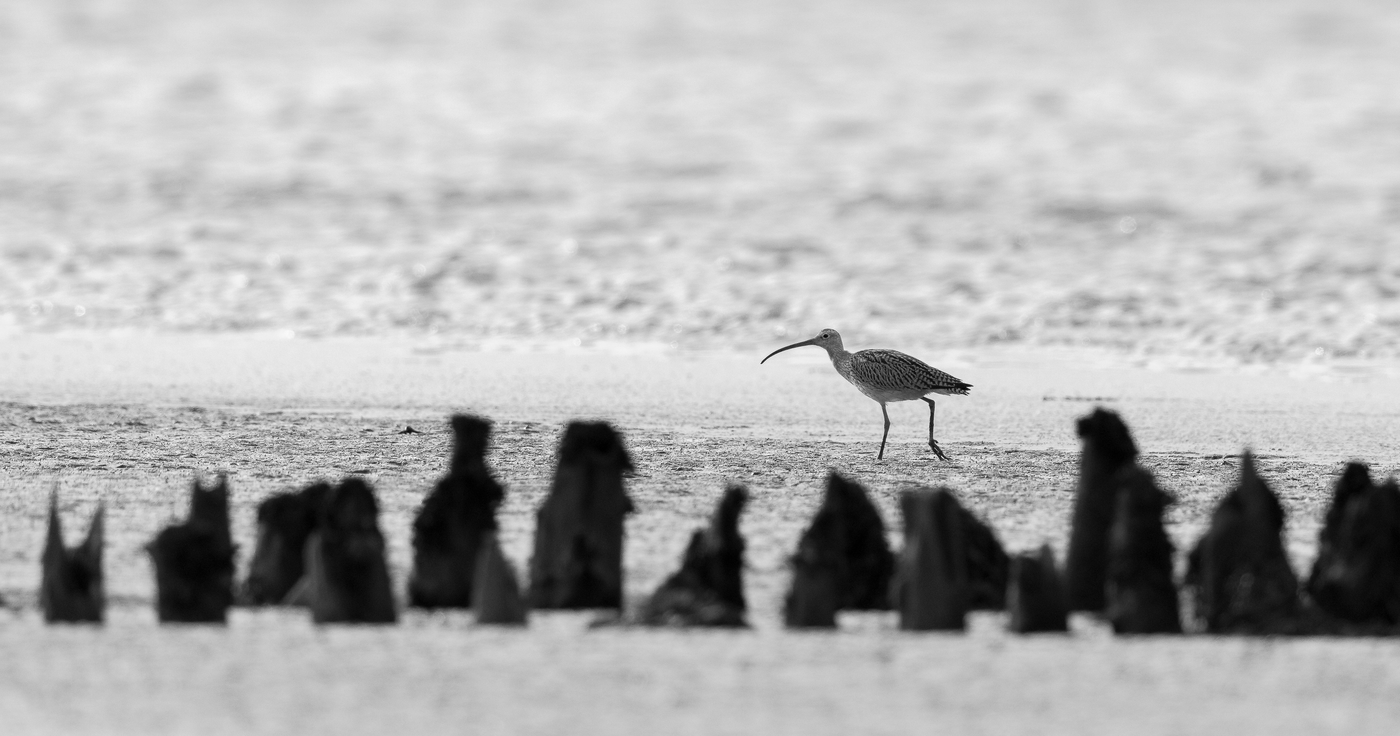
[32,409,1400,635]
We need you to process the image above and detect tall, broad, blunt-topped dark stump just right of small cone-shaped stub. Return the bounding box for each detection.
[529,421,633,609]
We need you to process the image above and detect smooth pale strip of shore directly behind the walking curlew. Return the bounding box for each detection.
[0,334,1400,462]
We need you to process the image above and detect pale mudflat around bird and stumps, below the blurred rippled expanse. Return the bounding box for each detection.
[0,333,1400,733]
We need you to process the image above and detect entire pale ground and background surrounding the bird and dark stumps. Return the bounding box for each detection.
[0,0,1400,736]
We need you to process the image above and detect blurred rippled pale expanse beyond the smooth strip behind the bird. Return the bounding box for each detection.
[0,0,1400,362]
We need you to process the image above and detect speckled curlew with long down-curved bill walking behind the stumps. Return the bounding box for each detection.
[759,330,972,460]
